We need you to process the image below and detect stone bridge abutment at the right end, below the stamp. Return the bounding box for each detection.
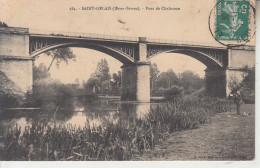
[206,46,255,97]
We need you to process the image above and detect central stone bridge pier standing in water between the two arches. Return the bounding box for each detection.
[121,62,150,102]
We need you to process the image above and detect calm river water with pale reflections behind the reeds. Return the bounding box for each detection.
[0,97,162,132]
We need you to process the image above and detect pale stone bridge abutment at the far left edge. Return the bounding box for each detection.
[0,28,33,96]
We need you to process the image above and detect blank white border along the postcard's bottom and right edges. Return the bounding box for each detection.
[0,1,260,168]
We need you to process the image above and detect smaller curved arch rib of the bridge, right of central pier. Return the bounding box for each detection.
[148,49,224,69]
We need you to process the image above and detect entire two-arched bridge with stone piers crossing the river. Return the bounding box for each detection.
[0,27,255,102]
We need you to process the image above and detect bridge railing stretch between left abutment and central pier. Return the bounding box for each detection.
[29,29,138,41]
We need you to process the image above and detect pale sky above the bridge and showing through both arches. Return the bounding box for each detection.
[0,0,254,83]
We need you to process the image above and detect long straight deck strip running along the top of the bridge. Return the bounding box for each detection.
[0,27,254,50]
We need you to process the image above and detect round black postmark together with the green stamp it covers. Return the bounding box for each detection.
[209,0,255,46]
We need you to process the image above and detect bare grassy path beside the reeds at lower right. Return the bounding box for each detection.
[134,104,255,160]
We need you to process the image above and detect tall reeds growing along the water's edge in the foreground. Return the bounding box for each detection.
[0,98,230,160]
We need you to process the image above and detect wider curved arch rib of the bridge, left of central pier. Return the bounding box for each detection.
[30,42,134,64]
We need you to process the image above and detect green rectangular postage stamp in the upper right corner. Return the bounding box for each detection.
[215,0,250,41]
